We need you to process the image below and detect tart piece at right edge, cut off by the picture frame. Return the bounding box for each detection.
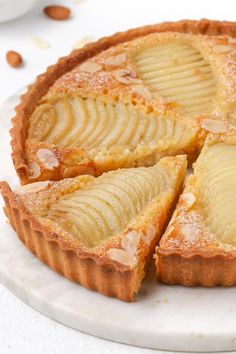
[156,130,236,286]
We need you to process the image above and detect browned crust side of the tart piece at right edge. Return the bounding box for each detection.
[156,247,236,287]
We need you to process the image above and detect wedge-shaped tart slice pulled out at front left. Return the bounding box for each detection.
[1,155,186,301]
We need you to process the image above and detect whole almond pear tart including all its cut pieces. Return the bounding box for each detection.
[1,20,236,301]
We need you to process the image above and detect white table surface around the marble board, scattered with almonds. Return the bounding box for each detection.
[0,0,236,354]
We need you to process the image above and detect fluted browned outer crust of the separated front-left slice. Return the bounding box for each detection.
[0,182,136,301]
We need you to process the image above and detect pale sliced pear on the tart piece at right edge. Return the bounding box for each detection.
[195,143,236,246]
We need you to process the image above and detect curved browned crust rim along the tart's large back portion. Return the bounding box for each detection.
[11,19,236,183]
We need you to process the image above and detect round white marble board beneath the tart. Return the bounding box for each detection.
[0,93,236,352]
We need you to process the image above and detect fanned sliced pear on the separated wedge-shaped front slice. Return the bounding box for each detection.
[48,166,172,247]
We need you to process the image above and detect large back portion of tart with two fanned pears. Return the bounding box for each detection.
[12,21,236,184]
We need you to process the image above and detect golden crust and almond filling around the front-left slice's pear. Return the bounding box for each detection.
[0,156,186,301]
